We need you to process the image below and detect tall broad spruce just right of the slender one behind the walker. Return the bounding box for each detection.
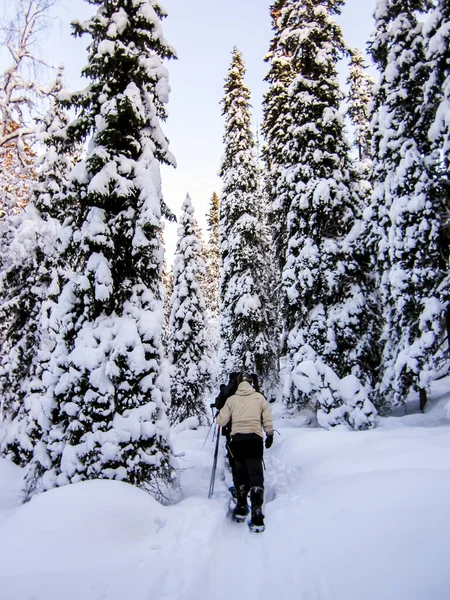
[274,0,377,429]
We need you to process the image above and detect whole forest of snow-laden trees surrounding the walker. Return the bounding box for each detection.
[0,0,450,500]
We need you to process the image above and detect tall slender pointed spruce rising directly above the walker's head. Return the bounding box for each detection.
[219,48,278,393]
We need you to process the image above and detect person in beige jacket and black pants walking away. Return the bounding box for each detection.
[216,372,273,531]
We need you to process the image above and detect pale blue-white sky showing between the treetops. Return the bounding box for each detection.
[0,0,375,260]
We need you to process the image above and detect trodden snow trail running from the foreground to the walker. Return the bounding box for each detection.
[140,432,331,600]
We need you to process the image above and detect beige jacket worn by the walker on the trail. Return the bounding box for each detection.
[216,381,273,437]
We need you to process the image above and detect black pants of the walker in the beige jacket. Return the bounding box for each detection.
[230,433,264,489]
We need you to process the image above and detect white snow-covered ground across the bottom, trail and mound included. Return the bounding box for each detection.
[0,379,450,600]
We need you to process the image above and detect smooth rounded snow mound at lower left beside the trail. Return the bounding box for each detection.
[0,480,165,576]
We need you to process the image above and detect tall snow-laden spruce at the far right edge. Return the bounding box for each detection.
[371,0,445,407]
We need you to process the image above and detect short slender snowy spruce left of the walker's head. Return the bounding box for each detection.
[168,194,211,423]
